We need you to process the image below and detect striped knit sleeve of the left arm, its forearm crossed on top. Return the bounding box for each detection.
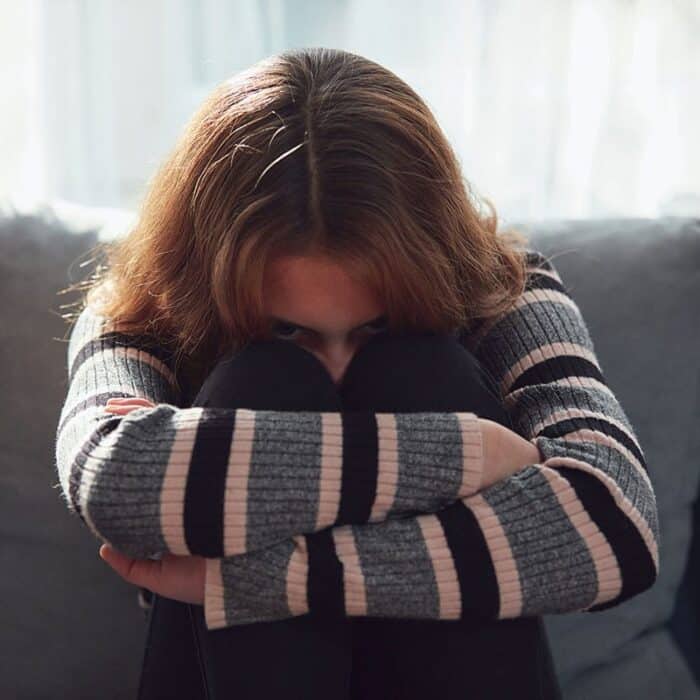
[55,307,483,558]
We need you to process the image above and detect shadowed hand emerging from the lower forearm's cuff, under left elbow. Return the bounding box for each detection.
[100,544,206,605]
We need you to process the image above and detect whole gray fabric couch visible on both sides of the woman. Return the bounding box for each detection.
[0,208,700,700]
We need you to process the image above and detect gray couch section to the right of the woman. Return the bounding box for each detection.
[513,217,700,700]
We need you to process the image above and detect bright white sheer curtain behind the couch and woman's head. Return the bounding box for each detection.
[0,0,700,227]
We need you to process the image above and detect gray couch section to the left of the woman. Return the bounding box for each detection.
[0,210,146,699]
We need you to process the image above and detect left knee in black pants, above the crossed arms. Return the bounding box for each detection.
[192,339,340,411]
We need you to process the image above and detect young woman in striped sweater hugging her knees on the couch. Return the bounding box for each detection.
[56,49,659,698]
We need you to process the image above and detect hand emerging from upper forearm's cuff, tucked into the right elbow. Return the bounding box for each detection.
[479,418,544,491]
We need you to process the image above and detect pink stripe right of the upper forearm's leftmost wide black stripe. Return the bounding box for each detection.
[224,408,256,556]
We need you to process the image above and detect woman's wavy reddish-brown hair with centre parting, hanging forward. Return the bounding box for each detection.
[61,47,527,400]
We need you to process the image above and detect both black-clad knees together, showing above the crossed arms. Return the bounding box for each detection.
[192,333,510,427]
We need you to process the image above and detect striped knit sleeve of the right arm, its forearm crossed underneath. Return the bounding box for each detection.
[200,251,660,629]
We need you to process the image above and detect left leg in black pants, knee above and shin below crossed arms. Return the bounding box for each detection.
[185,340,352,700]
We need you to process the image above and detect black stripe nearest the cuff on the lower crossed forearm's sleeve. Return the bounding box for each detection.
[304,527,346,619]
